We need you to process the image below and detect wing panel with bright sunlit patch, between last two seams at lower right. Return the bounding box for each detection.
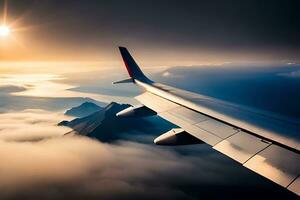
[244,144,300,187]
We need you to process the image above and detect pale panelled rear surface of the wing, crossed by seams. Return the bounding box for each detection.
[136,92,300,195]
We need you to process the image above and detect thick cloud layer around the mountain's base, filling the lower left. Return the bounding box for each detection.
[0,110,284,200]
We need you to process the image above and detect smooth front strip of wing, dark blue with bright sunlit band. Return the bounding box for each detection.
[147,83,300,151]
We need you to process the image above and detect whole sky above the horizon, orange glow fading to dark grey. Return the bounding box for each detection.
[0,0,300,69]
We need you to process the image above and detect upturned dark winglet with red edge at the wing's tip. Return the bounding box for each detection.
[119,47,150,81]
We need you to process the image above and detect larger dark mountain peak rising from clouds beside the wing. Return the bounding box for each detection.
[58,102,171,142]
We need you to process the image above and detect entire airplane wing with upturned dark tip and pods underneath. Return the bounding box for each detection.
[117,47,300,196]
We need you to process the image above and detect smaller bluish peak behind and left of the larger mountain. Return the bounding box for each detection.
[65,102,103,117]
